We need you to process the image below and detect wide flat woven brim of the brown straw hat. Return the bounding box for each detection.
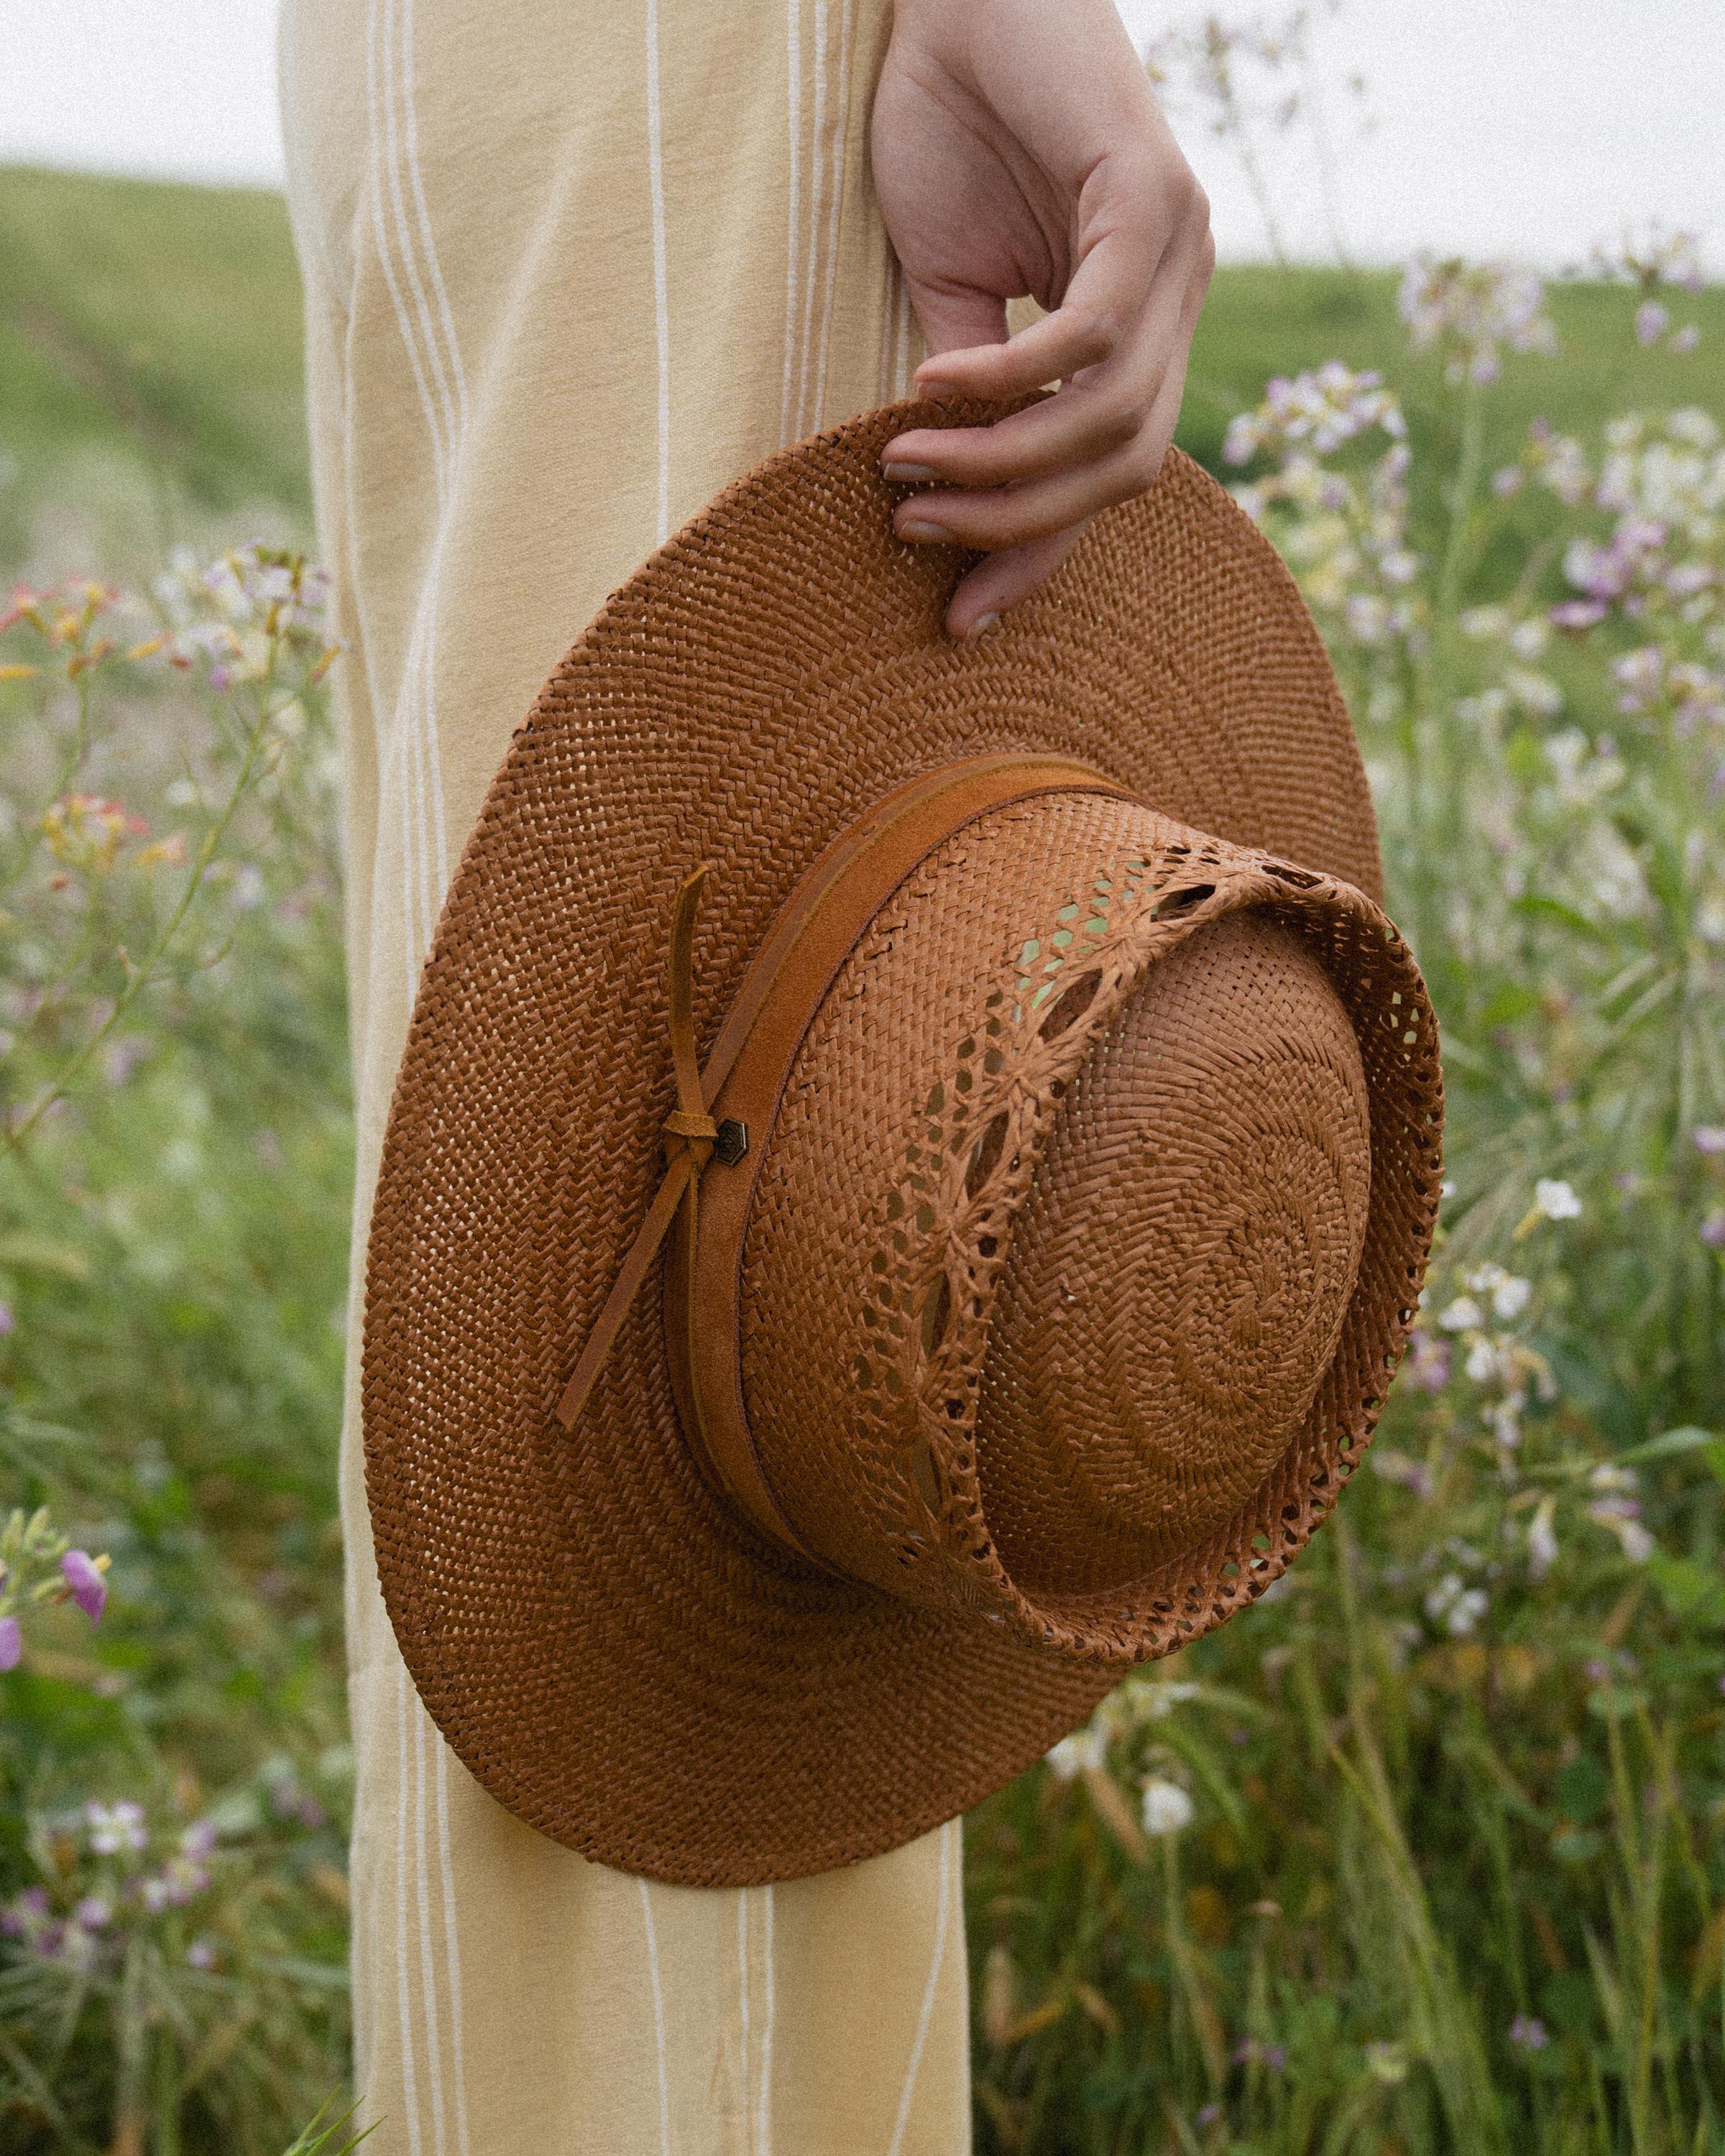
[362,405,1380,1886]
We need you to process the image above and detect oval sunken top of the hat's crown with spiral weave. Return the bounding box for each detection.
[977,914,1371,1593]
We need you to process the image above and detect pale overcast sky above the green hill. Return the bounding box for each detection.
[0,0,1725,274]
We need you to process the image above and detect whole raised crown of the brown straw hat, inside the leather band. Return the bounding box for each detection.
[742,793,1397,1658]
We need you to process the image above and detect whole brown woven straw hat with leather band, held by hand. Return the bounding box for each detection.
[362,405,1440,1884]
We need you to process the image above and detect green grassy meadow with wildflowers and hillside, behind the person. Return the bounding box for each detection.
[0,170,1725,2156]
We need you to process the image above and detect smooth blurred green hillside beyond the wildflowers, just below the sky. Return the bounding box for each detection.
[0,168,1725,558]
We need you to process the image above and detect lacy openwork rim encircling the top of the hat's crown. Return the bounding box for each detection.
[824,819,1443,1662]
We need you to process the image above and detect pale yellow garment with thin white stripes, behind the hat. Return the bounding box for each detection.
[282,0,970,2156]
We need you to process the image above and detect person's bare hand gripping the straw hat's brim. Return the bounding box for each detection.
[871,0,1216,638]
